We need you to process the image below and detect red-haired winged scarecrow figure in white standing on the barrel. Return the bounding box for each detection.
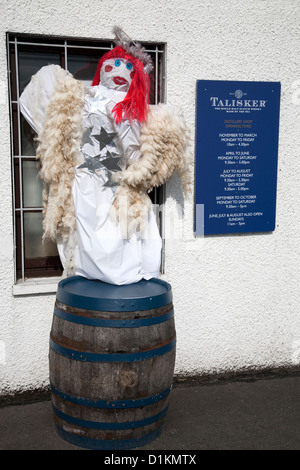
[20,28,189,285]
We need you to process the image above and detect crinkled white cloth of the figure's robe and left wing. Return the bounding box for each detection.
[20,66,162,285]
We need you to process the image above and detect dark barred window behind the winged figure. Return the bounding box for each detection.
[7,33,164,281]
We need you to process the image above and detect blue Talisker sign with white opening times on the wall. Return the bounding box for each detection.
[195,80,280,235]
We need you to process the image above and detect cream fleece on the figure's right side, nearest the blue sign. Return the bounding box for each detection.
[112,103,191,236]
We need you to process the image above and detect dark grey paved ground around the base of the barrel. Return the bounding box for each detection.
[0,377,300,451]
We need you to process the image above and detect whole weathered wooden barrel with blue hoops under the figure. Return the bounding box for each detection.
[49,276,176,450]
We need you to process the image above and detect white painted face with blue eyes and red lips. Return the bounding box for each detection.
[100,59,133,91]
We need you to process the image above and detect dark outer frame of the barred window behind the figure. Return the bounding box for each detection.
[6,32,166,283]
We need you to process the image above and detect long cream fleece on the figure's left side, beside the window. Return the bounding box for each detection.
[37,67,84,241]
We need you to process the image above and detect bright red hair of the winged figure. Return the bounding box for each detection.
[92,46,150,123]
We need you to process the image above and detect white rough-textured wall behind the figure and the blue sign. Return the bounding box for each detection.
[0,0,300,394]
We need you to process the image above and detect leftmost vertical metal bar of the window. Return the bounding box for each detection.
[15,38,25,281]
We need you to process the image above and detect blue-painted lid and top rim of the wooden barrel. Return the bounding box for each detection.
[56,276,172,312]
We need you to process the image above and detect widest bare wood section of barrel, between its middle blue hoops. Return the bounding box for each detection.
[49,349,175,400]
